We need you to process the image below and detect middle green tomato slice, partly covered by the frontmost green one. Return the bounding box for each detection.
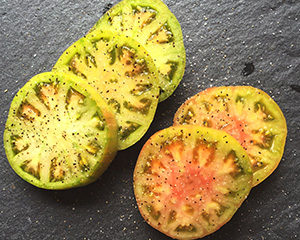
[53,31,159,150]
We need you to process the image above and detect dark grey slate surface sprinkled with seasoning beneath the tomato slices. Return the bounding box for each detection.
[0,0,300,240]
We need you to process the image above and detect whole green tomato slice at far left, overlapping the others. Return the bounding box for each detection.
[4,73,118,189]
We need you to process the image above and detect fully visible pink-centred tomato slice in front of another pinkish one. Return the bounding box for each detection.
[134,125,252,239]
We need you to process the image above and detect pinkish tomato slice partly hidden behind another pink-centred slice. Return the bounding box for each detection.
[174,86,287,186]
